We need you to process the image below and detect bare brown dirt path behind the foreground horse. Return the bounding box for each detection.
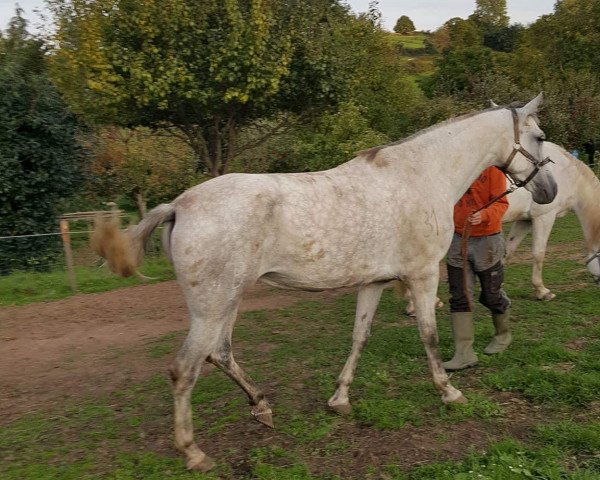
[0,281,346,424]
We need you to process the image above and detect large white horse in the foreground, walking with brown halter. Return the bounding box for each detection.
[93,95,556,471]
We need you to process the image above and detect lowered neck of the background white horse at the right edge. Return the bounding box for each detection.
[570,166,600,251]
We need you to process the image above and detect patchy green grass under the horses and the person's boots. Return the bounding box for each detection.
[0,215,600,480]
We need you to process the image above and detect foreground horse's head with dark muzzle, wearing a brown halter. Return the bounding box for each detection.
[496,93,558,204]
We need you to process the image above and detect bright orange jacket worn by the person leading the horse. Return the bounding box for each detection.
[454,167,508,237]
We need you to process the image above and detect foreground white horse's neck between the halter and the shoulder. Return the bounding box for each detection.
[386,110,513,205]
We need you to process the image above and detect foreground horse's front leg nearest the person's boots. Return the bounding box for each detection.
[408,274,467,403]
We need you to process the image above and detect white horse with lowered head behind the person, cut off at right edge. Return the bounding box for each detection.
[503,142,600,300]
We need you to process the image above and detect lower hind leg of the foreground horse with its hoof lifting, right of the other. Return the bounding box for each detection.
[208,326,273,428]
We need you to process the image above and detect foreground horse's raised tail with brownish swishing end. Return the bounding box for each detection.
[90,203,175,277]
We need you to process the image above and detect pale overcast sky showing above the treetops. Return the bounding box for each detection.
[0,0,556,31]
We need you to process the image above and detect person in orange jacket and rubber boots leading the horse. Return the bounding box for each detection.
[443,167,512,371]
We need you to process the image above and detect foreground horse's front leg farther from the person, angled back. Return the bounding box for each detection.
[327,283,385,415]
